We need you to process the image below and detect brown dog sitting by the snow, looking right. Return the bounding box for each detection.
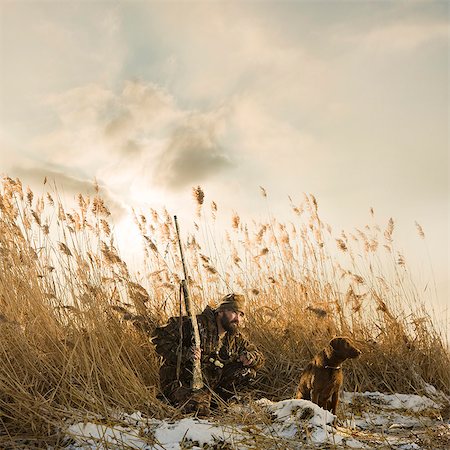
[296,337,361,414]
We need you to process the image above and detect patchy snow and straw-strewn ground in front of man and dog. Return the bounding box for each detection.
[66,392,450,450]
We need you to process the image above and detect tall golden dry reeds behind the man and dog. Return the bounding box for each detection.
[0,178,450,445]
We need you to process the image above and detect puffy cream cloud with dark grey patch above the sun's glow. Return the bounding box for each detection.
[25,80,234,198]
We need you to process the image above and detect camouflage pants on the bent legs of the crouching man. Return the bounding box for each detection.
[160,362,256,415]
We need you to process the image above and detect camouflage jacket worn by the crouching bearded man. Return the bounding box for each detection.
[152,306,264,386]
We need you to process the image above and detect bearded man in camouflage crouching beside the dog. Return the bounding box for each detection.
[152,294,264,415]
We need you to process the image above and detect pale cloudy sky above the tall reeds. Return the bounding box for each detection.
[0,0,449,316]
